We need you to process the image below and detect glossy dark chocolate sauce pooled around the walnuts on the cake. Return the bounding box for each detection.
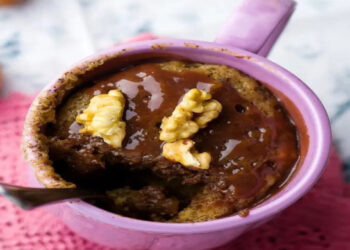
[83,63,298,197]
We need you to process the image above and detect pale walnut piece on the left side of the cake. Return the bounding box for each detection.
[76,90,126,148]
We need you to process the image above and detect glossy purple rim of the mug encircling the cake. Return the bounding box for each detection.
[41,39,331,234]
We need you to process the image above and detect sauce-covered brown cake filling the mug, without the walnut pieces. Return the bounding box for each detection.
[49,62,299,222]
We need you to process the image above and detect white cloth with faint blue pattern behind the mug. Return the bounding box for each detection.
[0,0,350,181]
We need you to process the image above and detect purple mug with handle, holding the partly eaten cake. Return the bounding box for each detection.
[27,0,331,250]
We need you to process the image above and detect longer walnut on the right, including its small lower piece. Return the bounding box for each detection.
[159,89,222,169]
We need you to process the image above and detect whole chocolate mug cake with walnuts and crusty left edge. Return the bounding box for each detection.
[23,60,300,223]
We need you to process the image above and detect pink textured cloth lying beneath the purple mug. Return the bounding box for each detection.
[0,34,350,250]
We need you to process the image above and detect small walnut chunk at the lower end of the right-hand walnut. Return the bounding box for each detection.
[163,139,211,169]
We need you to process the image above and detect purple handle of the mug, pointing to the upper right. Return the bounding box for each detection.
[215,0,296,56]
